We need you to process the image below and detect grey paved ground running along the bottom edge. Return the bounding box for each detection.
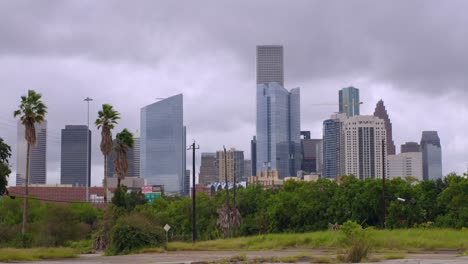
[9,250,468,264]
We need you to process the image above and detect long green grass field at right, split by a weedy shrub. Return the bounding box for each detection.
[167,229,468,251]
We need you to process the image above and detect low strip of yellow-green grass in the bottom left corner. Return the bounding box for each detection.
[0,248,79,262]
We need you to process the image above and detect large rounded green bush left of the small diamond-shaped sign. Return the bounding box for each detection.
[106,213,166,255]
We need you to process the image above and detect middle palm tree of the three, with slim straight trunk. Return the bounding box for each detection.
[95,104,120,203]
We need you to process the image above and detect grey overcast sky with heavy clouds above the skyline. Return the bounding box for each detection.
[0,0,468,185]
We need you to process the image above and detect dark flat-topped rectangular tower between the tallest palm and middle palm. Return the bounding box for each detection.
[60,125,91,186]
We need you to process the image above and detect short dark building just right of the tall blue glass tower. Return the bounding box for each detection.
[301,131,322,173]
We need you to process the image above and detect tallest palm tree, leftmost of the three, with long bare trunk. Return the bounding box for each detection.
[13,90,47,237]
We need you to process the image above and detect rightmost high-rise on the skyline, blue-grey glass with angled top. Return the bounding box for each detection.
[421,131,443,181]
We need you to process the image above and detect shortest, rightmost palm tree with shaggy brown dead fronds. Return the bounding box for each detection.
[114,128,134,189]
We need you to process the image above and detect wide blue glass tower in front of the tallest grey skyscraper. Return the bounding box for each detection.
[256,82,301,179]
